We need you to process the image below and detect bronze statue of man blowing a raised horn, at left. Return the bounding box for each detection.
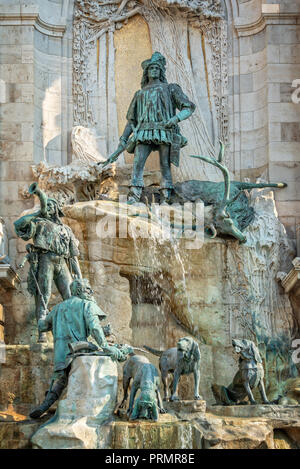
[14,183,81,342]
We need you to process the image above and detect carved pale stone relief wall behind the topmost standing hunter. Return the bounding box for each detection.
[73,0,228,180]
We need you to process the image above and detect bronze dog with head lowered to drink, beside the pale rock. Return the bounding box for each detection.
[119,355,165,421]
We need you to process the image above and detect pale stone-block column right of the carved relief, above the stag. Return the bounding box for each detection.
[229,0,300,240]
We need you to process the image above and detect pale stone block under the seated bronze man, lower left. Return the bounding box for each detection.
[31,356,118,449]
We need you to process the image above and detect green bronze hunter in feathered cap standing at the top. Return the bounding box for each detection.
[100,52,195,203]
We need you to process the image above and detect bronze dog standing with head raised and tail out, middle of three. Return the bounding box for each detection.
[144,337,201,401]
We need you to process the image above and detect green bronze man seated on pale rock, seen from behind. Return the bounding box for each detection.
[30,279,133,419]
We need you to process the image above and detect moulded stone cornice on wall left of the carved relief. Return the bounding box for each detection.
[0,12,66,37]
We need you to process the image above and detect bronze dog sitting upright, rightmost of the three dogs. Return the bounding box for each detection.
[212,339,270,405]
